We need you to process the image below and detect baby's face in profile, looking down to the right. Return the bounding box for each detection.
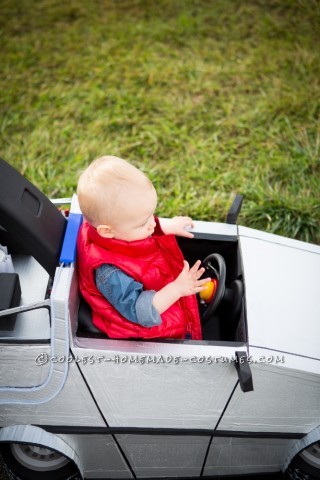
[112,185,157,242]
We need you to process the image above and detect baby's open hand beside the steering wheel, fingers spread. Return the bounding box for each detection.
[174,260,210,297]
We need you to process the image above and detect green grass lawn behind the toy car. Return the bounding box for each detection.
[0,0,320,243]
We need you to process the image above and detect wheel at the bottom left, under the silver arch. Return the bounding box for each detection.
[0,443,81,480]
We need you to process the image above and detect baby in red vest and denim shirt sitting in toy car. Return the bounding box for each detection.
[77,156,210,340]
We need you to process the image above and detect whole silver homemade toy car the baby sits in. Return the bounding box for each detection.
[0,160,320,480]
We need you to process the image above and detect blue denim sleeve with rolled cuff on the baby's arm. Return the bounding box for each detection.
[95,263,161,327]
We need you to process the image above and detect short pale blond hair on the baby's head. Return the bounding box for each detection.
[77,155,152,227]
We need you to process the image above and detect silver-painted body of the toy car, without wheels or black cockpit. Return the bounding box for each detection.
[0,193,320,479]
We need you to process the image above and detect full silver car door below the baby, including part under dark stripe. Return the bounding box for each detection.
[73,339,246,478]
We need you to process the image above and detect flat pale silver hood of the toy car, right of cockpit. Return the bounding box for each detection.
[238,227,320,360]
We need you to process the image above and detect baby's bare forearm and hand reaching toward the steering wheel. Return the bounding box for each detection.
[152,260,210,314]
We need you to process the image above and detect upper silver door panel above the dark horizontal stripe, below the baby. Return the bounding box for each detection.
[73,340,245,429]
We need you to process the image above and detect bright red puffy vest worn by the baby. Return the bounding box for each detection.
[77,218,201,340]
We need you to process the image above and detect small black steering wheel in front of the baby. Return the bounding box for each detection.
[201,253,226,324]
